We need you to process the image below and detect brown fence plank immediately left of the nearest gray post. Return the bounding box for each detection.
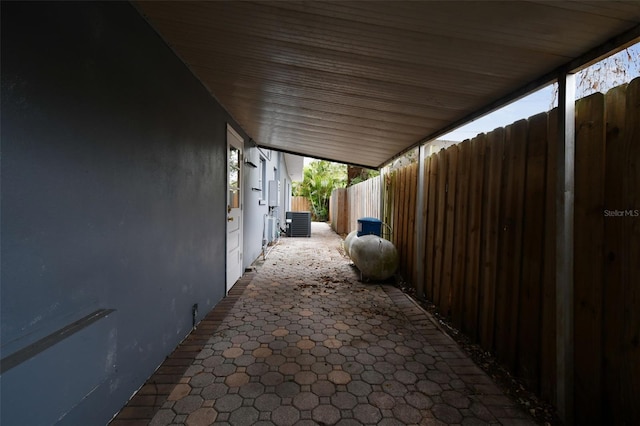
[540,108,558,401]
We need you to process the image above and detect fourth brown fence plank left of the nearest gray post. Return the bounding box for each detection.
[480,128,504,351]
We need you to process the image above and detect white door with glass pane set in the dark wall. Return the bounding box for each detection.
[227,125,243,292]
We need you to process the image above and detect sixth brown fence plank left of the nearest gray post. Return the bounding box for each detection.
[451,140,471,329]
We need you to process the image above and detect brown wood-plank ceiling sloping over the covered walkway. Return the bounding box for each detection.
[136,1,640,167]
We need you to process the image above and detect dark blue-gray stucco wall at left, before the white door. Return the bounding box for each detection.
[0,2,239,425]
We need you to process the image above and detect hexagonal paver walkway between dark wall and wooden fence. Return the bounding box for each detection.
[112,223,535,426]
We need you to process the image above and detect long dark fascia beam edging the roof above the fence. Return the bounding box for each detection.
[377,24,640,169]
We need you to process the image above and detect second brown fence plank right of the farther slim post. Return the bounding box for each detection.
[433,151,448,306]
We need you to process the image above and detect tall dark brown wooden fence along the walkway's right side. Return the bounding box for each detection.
[332,79,640,424]
